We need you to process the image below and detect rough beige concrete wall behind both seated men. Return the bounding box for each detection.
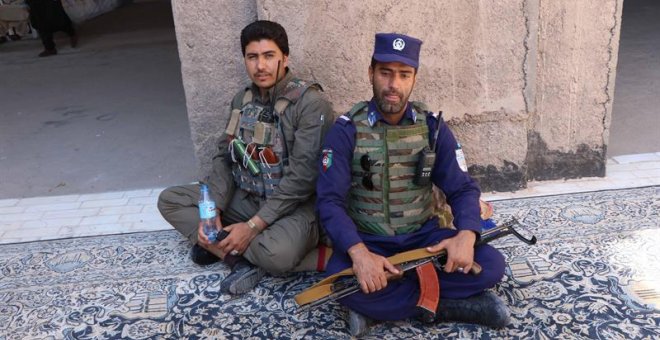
[173,0,622,191]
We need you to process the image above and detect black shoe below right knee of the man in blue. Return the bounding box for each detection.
[436,291,510,328]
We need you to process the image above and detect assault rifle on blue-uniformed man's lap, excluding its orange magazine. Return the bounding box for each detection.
[295,218,536,312]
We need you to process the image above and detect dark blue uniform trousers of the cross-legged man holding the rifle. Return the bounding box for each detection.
[327,219,504,320]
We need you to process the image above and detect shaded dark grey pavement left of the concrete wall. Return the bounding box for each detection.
[0,1,197,199]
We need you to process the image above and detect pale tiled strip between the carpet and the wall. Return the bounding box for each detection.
[0,152,660,244]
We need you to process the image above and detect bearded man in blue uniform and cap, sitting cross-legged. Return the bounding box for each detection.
[317,33,509,335]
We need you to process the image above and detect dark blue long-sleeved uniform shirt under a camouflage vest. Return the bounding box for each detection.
[316,99,481,253]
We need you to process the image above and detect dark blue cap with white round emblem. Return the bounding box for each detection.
[373,33,422,69]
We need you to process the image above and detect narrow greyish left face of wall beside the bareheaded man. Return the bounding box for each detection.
[172,0,257,178]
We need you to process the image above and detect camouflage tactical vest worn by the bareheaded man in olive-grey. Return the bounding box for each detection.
[226,78,319,198]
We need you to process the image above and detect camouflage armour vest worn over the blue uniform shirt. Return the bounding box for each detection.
[348,102,433,235]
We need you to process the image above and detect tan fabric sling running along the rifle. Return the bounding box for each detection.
[294,248,438,306]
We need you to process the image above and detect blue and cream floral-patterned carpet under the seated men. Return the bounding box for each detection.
[0,187,660,340]
